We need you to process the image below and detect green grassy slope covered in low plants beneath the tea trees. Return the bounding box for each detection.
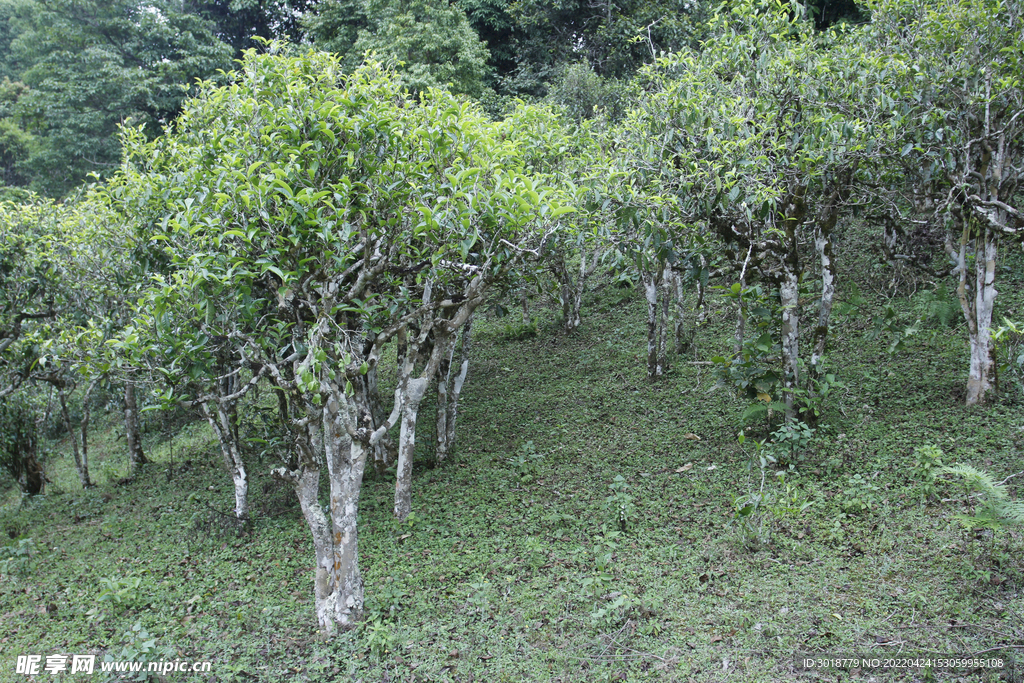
[0,227,1024,681]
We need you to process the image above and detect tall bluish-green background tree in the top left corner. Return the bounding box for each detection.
[5,0,231,195]
